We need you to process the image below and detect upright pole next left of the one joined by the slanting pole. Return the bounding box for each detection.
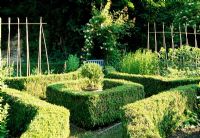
[26,17,30,76]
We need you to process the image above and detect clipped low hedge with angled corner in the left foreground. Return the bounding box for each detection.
[0,88,70,138]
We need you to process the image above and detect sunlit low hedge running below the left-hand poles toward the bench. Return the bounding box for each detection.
[4,72,78,99]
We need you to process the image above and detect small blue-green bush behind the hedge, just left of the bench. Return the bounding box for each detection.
[65,55,80,72]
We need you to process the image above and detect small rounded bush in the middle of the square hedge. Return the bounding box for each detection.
[80,63,104,89]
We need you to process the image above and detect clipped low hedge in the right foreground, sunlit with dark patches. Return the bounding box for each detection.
[122,85,199,138]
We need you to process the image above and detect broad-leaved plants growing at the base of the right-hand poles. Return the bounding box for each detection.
[159,45,200,78]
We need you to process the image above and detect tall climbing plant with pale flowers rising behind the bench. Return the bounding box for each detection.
[82,0,133,66]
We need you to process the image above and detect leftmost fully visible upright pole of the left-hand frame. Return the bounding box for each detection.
[7,17,11,77]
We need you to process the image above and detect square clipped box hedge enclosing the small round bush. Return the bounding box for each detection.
[46,79,144,129]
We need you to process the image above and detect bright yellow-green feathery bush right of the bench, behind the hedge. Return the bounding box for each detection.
[121,50,159,75]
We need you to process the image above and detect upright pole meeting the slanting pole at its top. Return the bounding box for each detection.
[38,17,42,74]
